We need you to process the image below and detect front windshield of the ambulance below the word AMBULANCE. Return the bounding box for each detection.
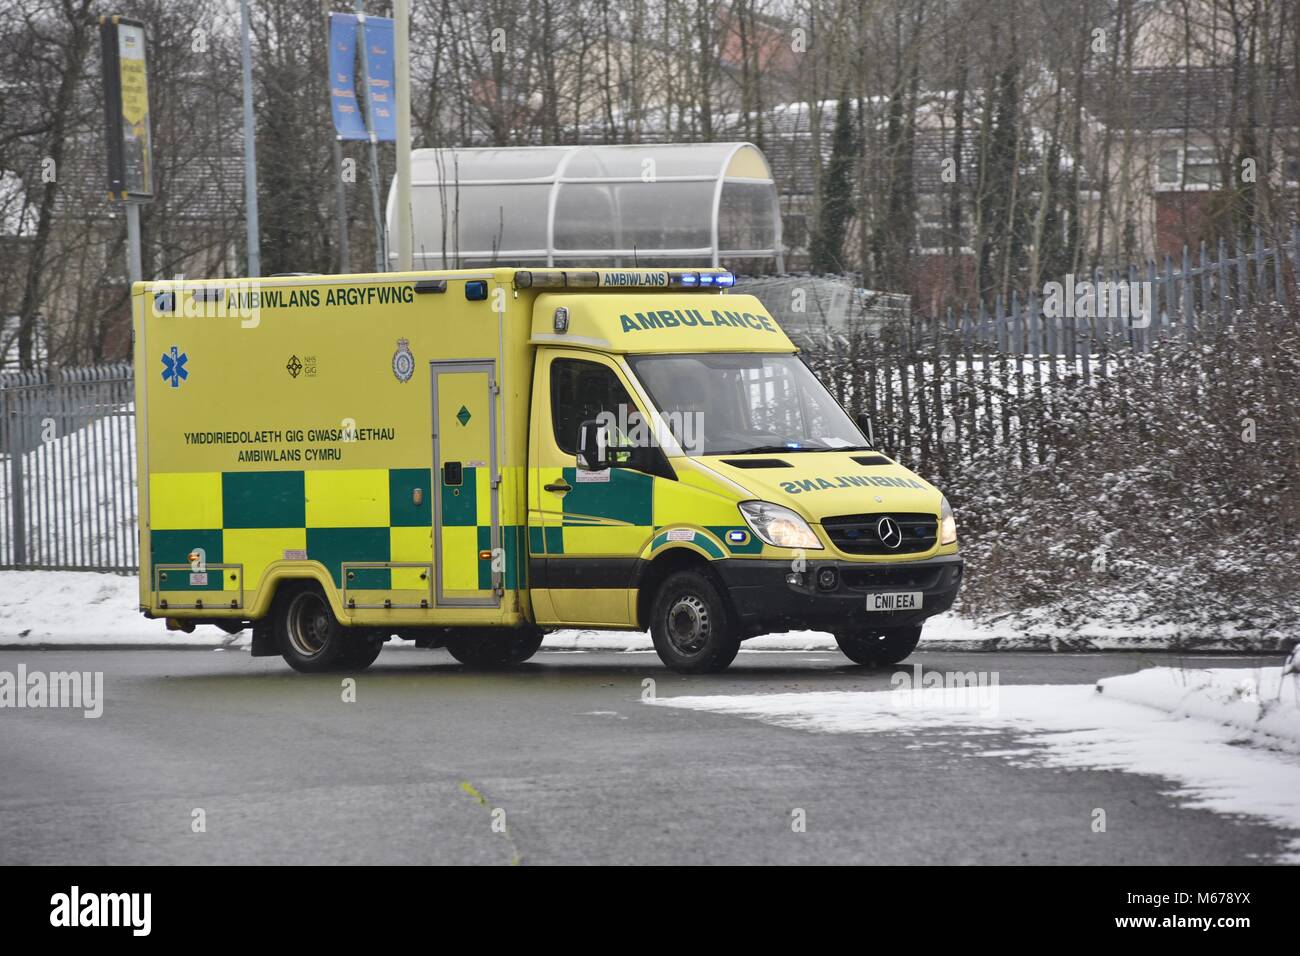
[628,352,868,455]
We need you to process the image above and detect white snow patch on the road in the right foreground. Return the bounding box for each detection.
[649,667,1300,864]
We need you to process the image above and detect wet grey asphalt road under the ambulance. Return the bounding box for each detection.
[0,649,1286,865]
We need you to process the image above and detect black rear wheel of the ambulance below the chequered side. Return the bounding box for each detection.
[273,584,380,674]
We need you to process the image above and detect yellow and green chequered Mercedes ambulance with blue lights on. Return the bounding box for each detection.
[133,268,962,672]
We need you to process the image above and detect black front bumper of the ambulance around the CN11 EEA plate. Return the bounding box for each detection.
[712,554,965,637]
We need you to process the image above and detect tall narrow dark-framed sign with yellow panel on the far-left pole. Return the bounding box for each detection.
[99,17,153,200]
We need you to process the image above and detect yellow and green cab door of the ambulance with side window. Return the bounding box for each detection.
[529,349,667,627]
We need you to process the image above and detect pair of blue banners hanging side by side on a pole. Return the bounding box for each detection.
[329,13,398,143]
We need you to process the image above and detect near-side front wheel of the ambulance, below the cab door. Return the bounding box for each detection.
[650,571,741,674]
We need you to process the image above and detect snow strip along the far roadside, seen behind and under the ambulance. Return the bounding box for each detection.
[0,571,1294,652]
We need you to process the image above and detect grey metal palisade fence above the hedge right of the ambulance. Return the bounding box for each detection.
[803,230,1300,475]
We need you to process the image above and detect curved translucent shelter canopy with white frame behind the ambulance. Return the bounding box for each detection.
[387,143,784,273]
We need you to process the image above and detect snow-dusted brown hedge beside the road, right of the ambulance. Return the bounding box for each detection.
[814,299,1300,646]
